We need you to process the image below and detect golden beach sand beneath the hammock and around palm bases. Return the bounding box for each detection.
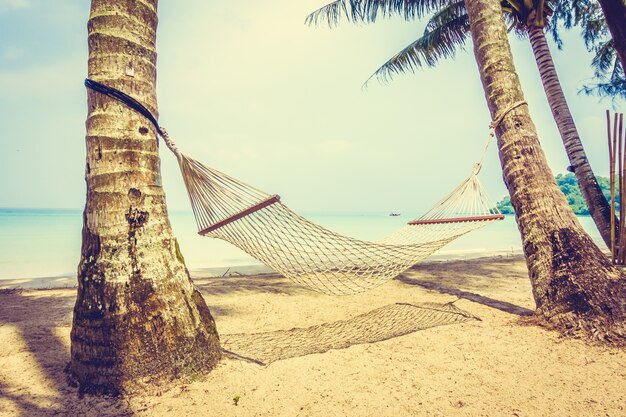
[0,256,626,417]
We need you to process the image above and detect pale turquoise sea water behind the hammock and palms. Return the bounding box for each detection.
[0,208,602,279]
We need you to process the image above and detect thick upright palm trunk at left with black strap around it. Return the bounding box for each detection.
[69,0,221,394]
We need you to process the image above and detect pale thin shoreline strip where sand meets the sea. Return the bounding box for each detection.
[0,249,522,290]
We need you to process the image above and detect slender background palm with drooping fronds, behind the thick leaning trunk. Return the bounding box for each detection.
[307,0,611,247]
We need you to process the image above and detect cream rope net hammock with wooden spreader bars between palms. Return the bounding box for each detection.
[85,80,504,295]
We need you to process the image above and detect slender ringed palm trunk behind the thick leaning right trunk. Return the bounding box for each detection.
[528,24,617,248]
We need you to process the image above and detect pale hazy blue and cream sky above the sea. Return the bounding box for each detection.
[0,0,621,215]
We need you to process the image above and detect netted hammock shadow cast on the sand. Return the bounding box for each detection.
[221,303,480,366]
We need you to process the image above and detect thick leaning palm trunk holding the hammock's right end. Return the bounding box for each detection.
[466,0,626,341]
